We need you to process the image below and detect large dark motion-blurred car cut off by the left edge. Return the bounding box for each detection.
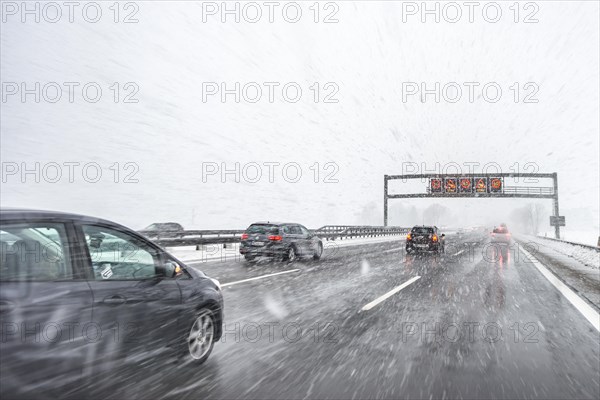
[0,209,223,397]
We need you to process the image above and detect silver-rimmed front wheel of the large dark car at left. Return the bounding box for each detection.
[186,308,215,364]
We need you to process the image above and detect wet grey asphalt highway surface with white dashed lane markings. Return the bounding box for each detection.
[77,236,600,399]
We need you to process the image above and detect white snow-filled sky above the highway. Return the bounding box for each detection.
[0,1,600,231]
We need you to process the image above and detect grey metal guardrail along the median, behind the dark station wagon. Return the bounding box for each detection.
[139,225,411,247]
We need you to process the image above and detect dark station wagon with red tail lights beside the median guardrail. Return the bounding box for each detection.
[240,222,323,262]
